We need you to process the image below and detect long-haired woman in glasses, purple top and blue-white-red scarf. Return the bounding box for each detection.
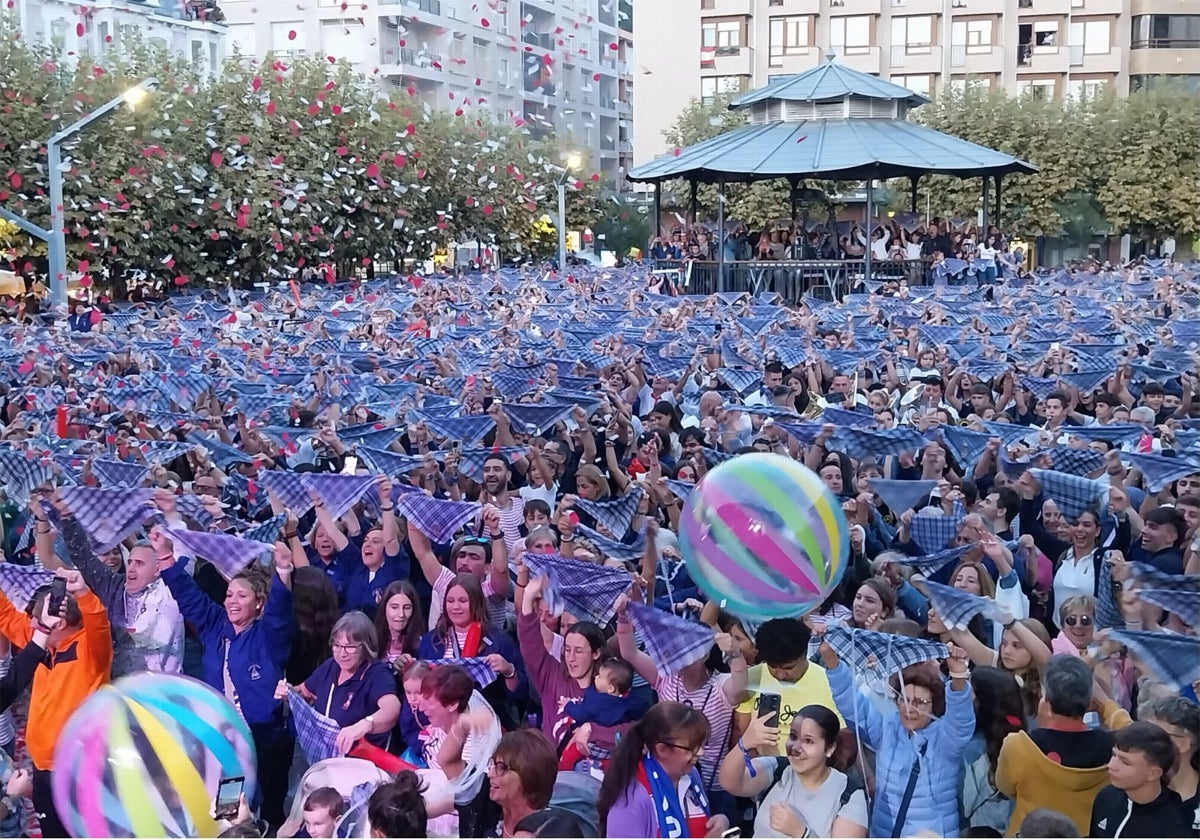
[596,703,730,838]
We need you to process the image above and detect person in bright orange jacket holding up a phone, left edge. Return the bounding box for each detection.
[0,569,113,838]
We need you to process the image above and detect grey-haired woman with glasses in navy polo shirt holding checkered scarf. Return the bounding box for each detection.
[275,612,400,754]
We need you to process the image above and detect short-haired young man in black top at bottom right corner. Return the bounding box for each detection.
[1088,721,1192,838]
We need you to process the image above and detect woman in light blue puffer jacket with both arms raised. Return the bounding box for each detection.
[821,642,976,838]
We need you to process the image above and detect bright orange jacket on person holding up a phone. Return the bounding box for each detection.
[0,592,113,770]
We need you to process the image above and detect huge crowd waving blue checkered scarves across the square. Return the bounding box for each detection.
[0,253,1200,838]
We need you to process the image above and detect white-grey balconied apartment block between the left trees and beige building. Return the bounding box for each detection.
[222,0,634,185]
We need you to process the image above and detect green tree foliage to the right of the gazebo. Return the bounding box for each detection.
[913,85,1200,240]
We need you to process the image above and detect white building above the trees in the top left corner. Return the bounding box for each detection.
[13,0,227,74]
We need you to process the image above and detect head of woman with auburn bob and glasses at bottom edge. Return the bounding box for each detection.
[487,730,558,838]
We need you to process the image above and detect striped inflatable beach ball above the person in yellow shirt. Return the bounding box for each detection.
[679,452,850,620]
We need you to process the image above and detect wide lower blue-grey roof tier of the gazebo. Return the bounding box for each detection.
[629,119,1037,184]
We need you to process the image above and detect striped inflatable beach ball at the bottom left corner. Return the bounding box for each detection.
[50,672,256,838]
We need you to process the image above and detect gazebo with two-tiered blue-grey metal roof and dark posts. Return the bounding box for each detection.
[628,54,1037,291]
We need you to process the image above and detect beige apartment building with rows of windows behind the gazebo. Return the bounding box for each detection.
[634,0,1200,162]
